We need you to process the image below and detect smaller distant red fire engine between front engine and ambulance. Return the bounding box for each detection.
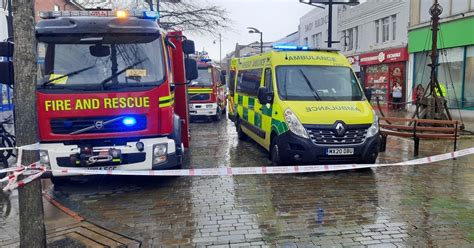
[188,58,226,121]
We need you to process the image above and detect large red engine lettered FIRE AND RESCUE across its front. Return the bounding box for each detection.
[32,10,197,182]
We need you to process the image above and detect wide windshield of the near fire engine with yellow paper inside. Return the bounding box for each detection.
[38,35,166,90]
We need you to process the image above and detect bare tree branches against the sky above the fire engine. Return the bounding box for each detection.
[77,0,231,35]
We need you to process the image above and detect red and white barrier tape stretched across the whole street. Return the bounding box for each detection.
[0,147,474,190]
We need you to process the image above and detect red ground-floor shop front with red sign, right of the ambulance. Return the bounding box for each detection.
[359,47,408,109]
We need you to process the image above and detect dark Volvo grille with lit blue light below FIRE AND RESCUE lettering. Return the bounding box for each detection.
[50,115,147,134]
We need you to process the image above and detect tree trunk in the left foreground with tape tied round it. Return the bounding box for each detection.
[13,0,46,247]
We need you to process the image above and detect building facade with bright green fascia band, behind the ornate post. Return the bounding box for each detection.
[408,0,474,110]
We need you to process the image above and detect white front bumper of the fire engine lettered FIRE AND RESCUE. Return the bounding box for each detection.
[40,137,183,177]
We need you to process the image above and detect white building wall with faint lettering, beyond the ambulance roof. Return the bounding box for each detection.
[299,7,339,48]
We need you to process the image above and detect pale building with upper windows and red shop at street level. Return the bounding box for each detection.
[338,0,410,108]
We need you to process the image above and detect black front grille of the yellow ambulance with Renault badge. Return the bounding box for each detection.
[306,127,367,145]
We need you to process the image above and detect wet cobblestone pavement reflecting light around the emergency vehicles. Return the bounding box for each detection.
[45,120,474,247]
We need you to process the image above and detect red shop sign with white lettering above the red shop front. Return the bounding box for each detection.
[359,47,408,65]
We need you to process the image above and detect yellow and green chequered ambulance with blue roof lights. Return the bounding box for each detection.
[229,46,380,165]
